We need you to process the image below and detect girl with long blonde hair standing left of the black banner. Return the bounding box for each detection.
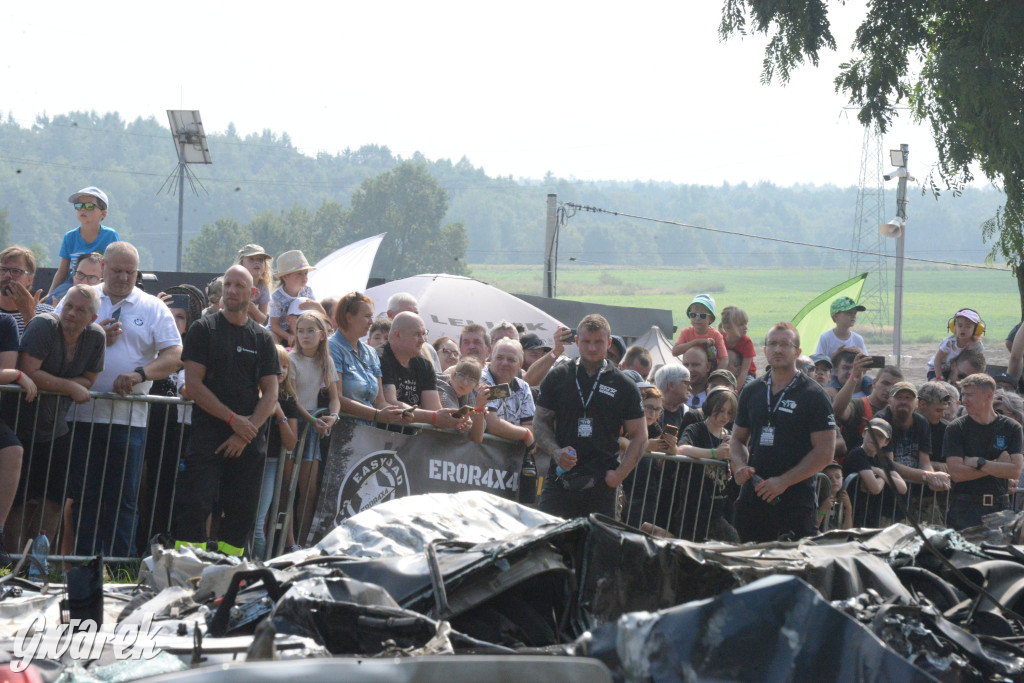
[286,310,341,540]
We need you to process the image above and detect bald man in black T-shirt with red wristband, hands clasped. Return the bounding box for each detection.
[175,265,281,556]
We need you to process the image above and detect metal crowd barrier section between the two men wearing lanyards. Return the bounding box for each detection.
[620,453,831,542]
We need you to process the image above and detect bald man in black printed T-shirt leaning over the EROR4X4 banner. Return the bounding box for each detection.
[380,311,470,429]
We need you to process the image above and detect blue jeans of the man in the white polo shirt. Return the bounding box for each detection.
[72,422,145,557]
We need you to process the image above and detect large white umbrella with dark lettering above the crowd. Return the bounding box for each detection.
[367,274,561,345]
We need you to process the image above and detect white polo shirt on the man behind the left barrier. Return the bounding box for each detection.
[56,285,181,427]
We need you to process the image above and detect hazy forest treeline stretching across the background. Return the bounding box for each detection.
[0,113,1002,278]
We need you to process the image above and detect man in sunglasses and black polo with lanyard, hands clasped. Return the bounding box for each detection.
[729,323,836,543]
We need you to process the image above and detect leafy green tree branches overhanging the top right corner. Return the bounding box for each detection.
[720,0,1024,315]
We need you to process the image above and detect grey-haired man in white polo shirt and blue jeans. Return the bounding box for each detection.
[58,242,181,557]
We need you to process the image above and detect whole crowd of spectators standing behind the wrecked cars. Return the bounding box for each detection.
[0,187,1024,562]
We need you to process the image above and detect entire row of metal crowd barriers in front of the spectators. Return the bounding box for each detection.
[0,385,962,562]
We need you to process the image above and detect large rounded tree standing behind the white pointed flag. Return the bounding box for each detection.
[348,162,469,280]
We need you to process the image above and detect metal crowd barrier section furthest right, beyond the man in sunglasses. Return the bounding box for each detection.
[833,472,949,528]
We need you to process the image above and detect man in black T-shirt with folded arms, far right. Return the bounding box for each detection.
[943,374,1024,529]
